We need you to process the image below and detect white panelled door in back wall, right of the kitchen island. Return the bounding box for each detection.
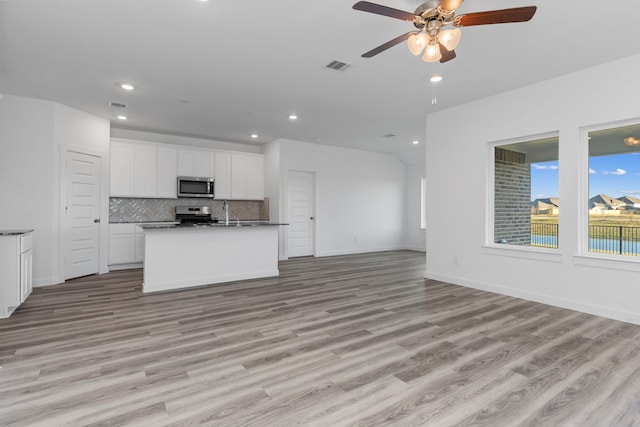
[288,171,315,257]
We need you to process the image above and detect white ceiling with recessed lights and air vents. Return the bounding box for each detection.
[0,0,640,162]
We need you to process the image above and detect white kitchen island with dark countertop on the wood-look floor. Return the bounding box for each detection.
[140,222,285,293]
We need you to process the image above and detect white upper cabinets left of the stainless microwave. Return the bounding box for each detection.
[111,139,177,198]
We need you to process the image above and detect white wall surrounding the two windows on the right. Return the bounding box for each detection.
[425,56,640,323]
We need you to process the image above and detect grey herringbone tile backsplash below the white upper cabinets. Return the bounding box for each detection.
[109,197,269,222]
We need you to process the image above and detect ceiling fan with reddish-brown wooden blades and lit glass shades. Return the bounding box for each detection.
[353,0,537,63]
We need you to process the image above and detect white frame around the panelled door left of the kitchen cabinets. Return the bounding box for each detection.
[58,144,110,281]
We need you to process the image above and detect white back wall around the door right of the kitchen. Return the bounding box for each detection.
[277,140,405,258]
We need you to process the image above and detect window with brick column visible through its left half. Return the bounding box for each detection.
[492,136,560,248]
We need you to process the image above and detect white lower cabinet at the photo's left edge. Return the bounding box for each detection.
[0,232,33,319]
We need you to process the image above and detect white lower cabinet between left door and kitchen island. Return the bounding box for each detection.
[109,223,144,270]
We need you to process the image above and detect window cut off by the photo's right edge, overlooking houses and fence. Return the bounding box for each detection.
[586,124,640,256]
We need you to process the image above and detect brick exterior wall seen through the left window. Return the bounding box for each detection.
[493,147,531,246]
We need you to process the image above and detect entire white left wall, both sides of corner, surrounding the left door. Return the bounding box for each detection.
[0,95,109,286]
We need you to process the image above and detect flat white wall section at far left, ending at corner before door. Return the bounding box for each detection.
[0,95,59,285]
